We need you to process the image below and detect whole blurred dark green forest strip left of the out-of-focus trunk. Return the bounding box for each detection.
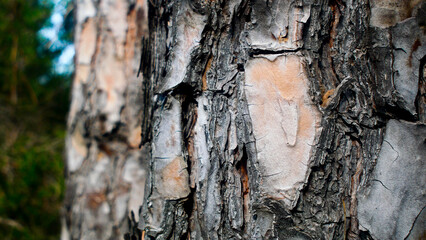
[0,0,73,239]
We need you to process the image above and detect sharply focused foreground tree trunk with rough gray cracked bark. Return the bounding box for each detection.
[65,0,426,239]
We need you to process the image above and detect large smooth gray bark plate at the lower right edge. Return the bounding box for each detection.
[358,120,426,239]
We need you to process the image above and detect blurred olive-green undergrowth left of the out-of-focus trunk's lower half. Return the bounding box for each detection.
[0,116,65,239]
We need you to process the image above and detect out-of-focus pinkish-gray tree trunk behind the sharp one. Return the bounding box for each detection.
[62,0,148,240]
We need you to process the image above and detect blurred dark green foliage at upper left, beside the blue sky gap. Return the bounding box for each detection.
[0,0,58,104]
